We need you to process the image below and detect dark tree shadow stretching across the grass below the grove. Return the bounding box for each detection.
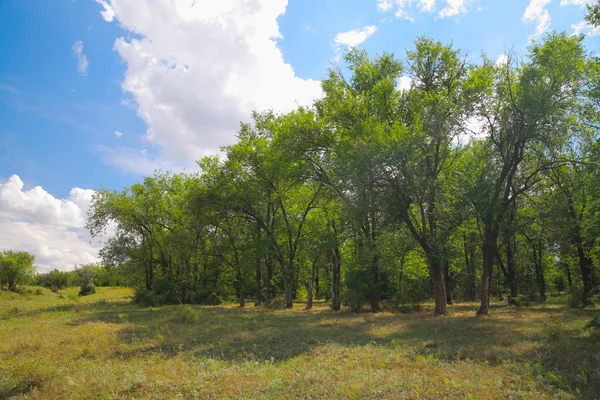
[72,303,600,393]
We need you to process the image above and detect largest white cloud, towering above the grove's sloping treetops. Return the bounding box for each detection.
[101,0,322,167]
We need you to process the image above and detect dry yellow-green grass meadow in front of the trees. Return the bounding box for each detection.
[0,288,600,399]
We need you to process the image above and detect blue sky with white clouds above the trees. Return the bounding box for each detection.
[0,0,600,272]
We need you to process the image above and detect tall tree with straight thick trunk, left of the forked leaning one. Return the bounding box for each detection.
[383,38,481,315]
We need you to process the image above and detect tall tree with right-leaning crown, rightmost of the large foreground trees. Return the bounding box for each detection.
[470,33,585,315]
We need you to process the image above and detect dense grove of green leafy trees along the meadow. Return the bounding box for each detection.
[88,33,600,315]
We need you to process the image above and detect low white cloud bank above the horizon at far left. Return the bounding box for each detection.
[0,175,105,272]
